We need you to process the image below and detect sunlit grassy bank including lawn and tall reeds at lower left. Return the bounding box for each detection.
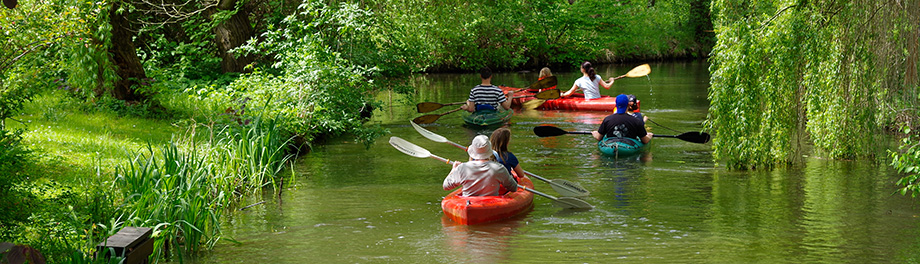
[0,93,290,263]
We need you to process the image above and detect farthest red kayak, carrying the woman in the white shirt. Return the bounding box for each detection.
[501,87,638,112]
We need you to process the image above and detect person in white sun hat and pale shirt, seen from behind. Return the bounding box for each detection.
[444,135,517,196]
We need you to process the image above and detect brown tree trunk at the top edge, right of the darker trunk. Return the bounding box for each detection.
[205,0,253,72]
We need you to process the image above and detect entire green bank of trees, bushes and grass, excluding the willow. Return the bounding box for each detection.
[0,0,712,263]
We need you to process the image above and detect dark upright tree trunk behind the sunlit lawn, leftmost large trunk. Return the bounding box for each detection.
[108,1,147,101]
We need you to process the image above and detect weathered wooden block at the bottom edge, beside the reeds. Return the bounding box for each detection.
[96,226,153,264]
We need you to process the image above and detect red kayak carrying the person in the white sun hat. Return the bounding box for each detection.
[441,177,533,225]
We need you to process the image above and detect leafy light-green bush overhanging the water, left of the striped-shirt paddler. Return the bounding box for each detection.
[230,3,383,144]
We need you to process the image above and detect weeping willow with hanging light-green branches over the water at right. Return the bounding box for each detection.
[707,0,920,169]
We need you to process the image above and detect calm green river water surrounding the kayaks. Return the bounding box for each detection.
[194,62,920,263]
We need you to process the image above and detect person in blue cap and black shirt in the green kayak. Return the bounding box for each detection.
[591,94,652,144]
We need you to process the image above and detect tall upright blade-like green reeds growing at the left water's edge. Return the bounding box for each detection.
[114,119,292,260]
